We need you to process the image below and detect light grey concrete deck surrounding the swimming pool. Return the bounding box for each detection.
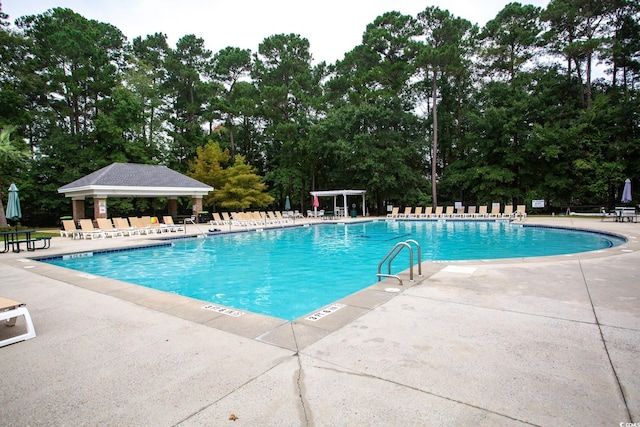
[0,217,640,426]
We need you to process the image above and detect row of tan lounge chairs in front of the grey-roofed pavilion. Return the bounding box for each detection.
[60,216,184,239]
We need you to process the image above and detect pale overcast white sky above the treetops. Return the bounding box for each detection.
[0,0,549,63]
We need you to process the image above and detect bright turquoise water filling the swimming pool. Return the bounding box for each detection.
[46,221,624,320]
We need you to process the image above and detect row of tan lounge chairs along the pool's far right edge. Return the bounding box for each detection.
[387,203,527,219]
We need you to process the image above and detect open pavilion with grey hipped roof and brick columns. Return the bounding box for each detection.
[58,163,213,220]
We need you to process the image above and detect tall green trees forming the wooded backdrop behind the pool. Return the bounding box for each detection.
[0,0,640,223]
